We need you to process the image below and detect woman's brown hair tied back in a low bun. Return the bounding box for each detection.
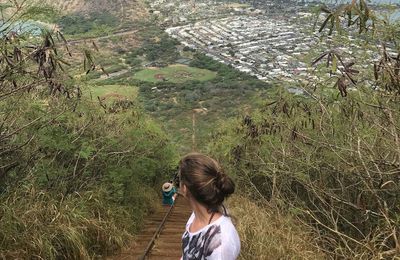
[179,153,235,212]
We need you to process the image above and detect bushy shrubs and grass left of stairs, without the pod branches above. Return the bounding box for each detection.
[0,95,176,259]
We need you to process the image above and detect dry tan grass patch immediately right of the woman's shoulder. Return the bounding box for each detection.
[228,195,326,260]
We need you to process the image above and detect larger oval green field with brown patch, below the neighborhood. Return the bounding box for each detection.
[133,64,217,83]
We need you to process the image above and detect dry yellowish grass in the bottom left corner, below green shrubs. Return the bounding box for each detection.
[0,186,135,260]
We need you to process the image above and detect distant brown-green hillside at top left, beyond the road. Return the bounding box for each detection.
[18,0,149,39]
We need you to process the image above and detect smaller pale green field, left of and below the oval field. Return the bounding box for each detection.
[87,85,138,103]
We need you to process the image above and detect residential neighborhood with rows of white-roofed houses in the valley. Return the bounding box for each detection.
[153,0,396,81]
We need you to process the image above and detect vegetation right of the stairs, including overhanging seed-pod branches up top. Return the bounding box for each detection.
[208,1,400,259]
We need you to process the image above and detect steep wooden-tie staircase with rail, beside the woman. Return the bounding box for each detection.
[109,196,191,260]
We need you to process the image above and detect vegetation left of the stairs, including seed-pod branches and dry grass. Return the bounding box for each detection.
[0,3,177,259]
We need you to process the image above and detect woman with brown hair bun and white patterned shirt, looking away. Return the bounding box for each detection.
[179,153,240,260]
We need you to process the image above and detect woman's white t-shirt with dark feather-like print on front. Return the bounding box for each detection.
[182,213,240,260]
